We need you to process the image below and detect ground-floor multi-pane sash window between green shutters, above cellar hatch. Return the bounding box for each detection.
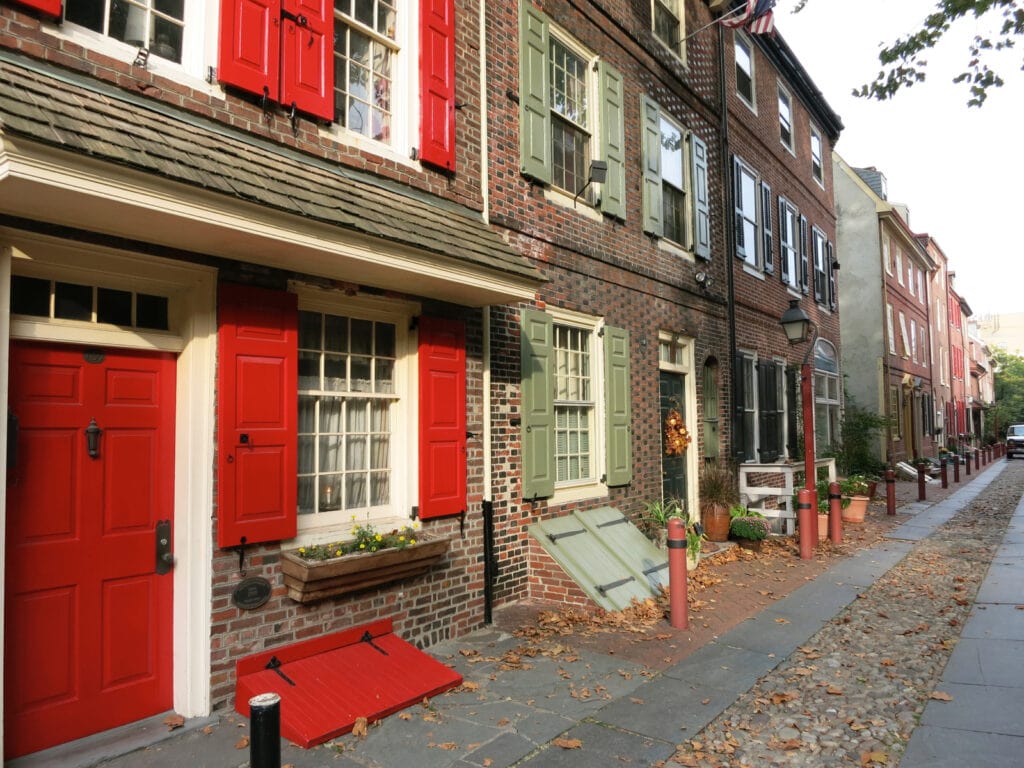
[554,325,595,482]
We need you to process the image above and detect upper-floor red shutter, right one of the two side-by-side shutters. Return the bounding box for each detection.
[281,0,334,120]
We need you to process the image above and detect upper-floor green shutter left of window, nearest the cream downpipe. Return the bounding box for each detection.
[519,0,551,184]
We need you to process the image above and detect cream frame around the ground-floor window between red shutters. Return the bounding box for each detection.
[289,283,421,546]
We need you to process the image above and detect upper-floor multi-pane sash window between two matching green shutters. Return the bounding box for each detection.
[549,36,590,195]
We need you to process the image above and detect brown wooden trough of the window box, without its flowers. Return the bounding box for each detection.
[281,536,451,603]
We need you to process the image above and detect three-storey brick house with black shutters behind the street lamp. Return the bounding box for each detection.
[724,15,843,520]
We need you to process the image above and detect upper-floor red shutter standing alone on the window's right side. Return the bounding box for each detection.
[420,0,455,171]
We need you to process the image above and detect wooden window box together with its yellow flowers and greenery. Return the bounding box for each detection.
[281,523,449,603]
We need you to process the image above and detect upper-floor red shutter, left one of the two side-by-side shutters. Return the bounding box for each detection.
[217,0,281,100]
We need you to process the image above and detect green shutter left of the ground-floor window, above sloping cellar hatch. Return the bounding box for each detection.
[519,309,555,499]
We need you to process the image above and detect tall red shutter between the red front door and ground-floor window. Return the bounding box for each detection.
[217,285,299,547]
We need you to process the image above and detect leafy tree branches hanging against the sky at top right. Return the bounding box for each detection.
[795,0,1024,106]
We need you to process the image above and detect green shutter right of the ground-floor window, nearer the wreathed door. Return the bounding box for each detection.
[604,327,633,485]
